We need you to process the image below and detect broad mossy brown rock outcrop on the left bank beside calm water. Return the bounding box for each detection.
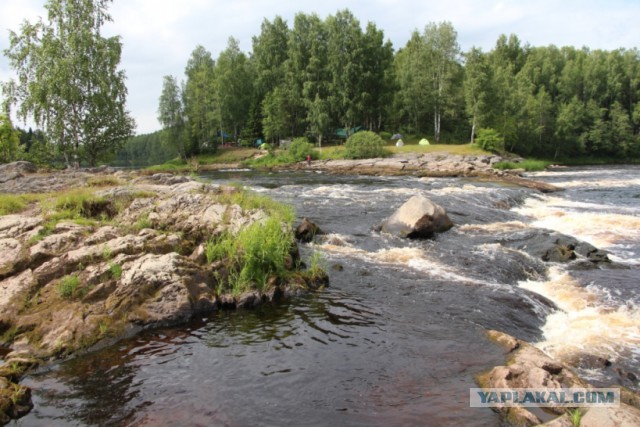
[0,172,328,424]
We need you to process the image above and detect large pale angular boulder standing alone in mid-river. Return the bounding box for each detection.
[381,194,453,238]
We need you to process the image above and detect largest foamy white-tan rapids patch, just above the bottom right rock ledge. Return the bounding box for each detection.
[520,267,640,361]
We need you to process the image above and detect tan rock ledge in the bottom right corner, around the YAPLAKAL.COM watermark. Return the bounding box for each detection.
[476,330,640,427]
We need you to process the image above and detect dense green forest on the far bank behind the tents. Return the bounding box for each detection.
[8,10,640,165]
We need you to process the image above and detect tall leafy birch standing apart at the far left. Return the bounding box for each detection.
[4,0,135,165]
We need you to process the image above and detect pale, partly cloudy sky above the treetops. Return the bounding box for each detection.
[0,0,640,134]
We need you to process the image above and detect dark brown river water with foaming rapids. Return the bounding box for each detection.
[17,167,640,426]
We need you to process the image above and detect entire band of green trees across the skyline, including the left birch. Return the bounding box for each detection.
[0,0,640,165]
